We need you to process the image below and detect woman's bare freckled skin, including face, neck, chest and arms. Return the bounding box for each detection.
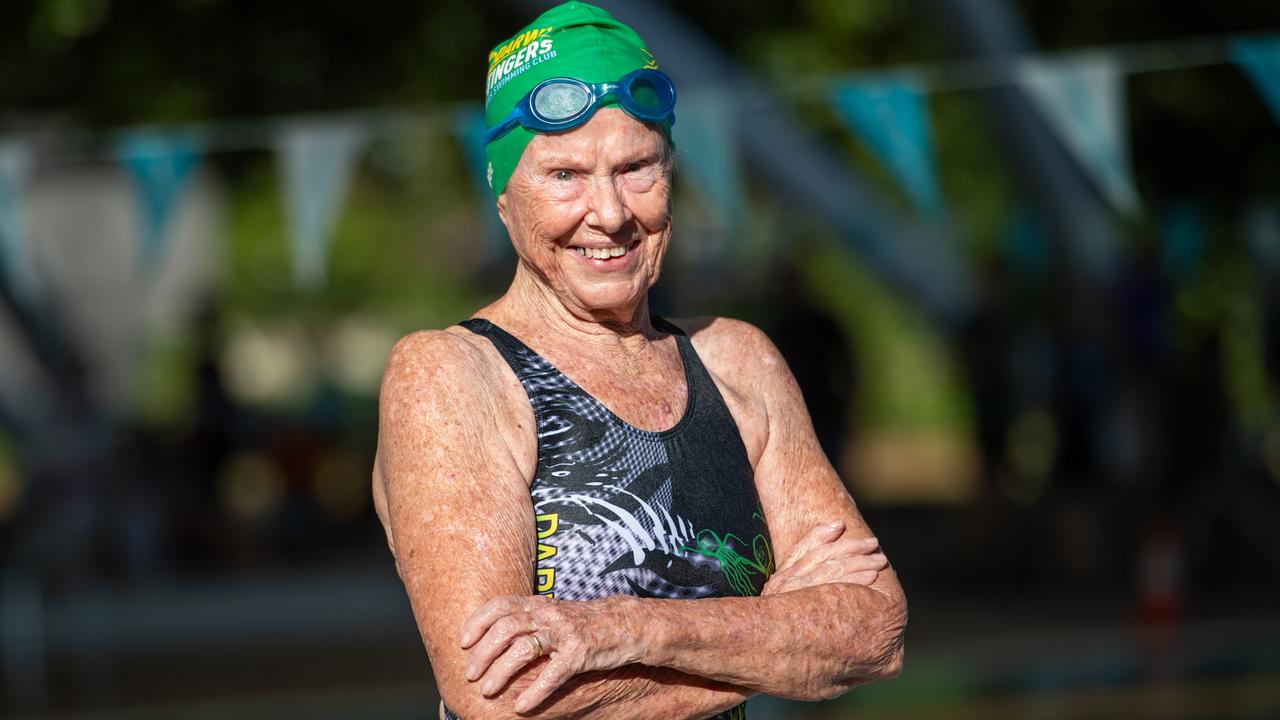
[372,108,906,720]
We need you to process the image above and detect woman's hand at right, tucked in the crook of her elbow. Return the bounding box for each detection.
[760,520,888,594]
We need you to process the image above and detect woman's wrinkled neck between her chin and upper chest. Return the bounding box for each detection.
[485,263,660,347]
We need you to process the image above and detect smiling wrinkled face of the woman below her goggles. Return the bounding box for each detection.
[498,108,671,319]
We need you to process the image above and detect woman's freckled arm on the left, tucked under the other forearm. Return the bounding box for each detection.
[374,332,751,720]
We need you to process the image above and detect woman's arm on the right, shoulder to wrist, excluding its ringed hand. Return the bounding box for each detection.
[622,313,906,700]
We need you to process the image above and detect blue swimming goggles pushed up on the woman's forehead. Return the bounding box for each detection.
[483,68,676,145]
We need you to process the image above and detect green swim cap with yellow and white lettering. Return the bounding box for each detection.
[484,1,671,196]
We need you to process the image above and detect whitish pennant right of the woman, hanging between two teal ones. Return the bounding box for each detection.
[1015,53,1140,215]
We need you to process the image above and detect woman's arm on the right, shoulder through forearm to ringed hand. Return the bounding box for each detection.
[463,320,906,705]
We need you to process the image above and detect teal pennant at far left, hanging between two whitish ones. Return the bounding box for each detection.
[116,132,200,268]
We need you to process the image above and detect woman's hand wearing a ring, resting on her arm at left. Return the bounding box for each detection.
[461,596,643,712]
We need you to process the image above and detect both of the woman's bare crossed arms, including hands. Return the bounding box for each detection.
[375,320,906,720]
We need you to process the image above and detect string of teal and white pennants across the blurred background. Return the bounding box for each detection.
[0,32,1280,292]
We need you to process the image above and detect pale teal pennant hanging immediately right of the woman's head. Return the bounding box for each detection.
[672,90,745,227]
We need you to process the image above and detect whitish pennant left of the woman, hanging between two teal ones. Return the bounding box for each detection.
[276,122,366,287]
